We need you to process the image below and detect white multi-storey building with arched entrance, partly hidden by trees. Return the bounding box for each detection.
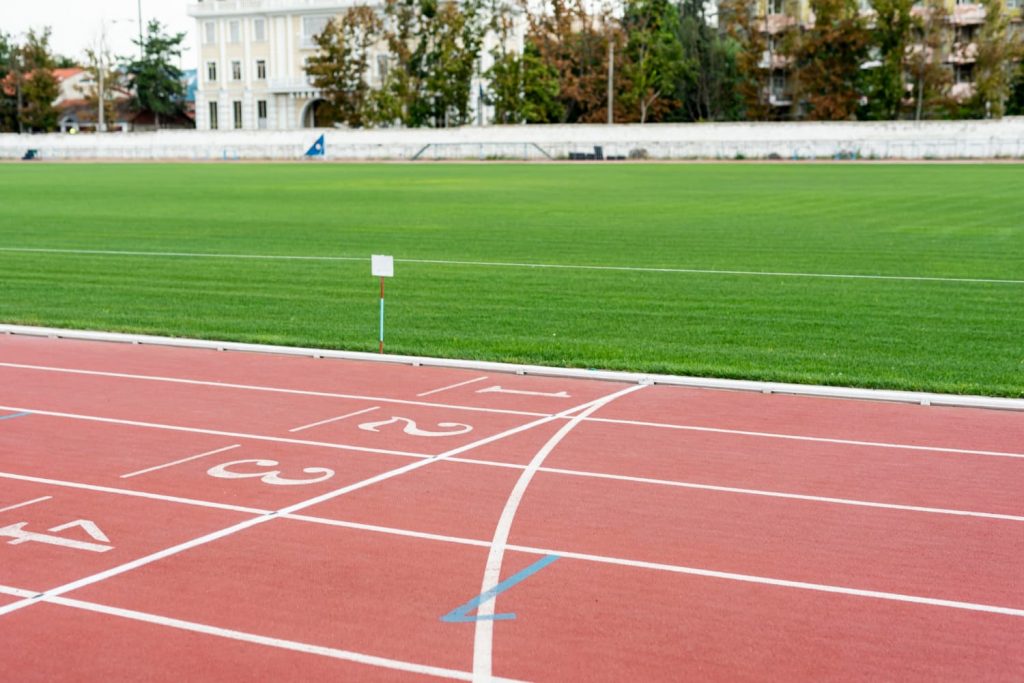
[188,0,512,130]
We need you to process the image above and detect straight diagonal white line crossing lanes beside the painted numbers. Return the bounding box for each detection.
[0,389,614,615]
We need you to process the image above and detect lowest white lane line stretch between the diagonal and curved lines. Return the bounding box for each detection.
[43,596,501,681]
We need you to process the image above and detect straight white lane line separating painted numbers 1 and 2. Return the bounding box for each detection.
[0,362,1024,458]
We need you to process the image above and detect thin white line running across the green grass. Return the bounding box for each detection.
[0,247,1024,285]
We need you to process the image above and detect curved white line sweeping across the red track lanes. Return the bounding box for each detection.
[473,384,646,683]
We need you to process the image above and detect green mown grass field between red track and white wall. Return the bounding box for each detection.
[0,164,1024,396]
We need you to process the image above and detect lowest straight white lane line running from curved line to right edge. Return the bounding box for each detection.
[508,545,1024,616]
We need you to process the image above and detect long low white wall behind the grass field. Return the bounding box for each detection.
[6,118,1024,160]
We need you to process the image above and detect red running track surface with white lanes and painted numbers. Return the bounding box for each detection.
[0,336,1024,681]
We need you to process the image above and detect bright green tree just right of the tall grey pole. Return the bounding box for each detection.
[623,0,694,123]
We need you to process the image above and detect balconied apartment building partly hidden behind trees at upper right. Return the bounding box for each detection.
[758,0,1024,116]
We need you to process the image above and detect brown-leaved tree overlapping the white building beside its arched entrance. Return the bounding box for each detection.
[306,5,383,128]
